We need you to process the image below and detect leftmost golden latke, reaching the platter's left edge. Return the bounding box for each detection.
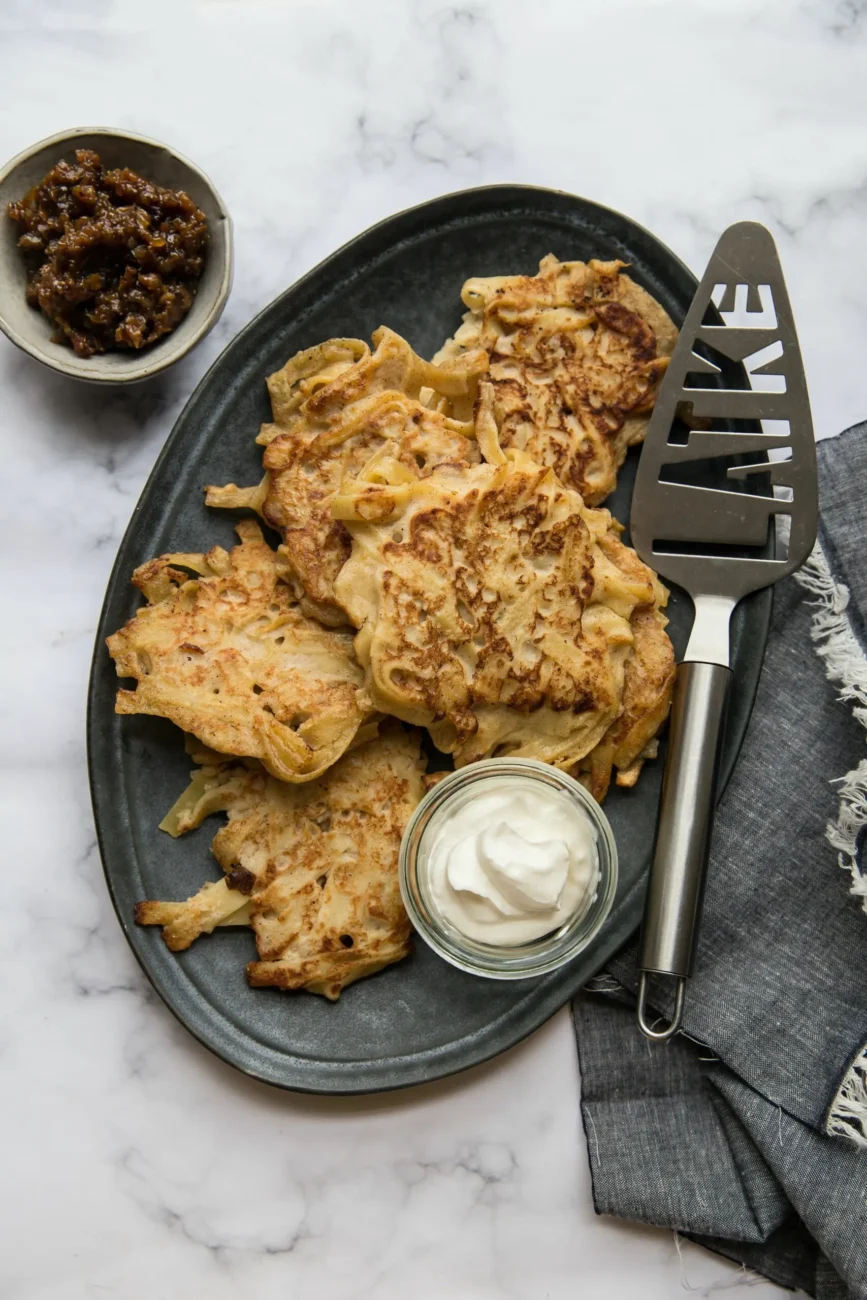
[107,520,373,781]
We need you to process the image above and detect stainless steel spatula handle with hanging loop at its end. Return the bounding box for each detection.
[638,663,732,1040]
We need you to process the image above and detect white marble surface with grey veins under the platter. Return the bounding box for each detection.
[0,0,867,1300]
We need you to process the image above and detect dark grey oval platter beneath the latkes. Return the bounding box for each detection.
[88,185,771,1093]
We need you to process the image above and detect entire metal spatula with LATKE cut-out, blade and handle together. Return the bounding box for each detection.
[630,221,818,1040]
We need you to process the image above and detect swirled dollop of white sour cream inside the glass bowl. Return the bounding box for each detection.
[428,776,599,946]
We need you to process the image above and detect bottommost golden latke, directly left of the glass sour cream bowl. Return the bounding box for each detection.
[135,724,424,998]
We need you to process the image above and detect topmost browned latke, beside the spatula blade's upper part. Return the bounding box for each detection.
[434,256,677,506]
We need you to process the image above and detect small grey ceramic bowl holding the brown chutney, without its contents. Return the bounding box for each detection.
[0,126,231,384]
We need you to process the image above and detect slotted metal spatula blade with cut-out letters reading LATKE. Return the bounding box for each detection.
[630,221,818,601]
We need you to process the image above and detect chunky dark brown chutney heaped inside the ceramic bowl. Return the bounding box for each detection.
[9,150,208,356]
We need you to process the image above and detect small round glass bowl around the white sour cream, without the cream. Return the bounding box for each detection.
[399,758,617,979]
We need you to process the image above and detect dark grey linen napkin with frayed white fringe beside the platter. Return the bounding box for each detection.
[573,424,867,1300]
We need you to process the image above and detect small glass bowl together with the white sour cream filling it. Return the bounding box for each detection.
[400,758,617,979]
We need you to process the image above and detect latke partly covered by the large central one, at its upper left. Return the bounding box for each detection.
[205,328,487,625]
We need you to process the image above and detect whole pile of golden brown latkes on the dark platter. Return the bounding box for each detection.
[108,257,676,998]
